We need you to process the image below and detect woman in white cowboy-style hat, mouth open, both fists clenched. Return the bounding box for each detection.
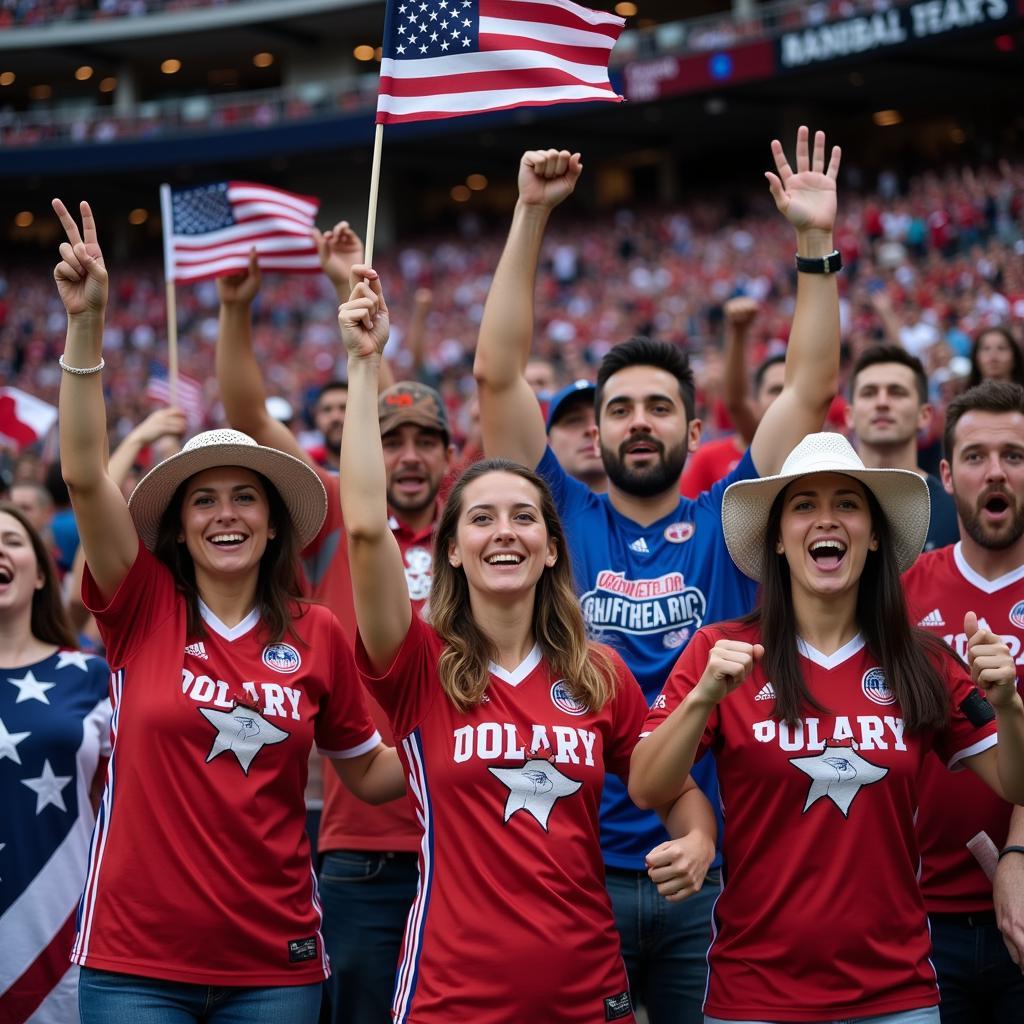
[630,433,1024,1024]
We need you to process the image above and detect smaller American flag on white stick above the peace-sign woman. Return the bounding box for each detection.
[161,181,321,281]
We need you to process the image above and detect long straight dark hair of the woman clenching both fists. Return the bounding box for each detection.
[744,486,958,732]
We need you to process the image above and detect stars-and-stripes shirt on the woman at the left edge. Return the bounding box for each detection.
[0,650,111,1024]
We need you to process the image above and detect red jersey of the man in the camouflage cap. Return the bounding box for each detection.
[316,512,434,853]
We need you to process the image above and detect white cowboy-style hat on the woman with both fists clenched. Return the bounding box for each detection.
[722,432,932,581]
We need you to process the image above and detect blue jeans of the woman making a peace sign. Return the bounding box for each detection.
[78,967,324,1024]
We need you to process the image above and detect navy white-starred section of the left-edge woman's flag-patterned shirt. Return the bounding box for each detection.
[0,650,110,916]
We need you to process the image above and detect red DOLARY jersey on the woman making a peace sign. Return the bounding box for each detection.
[72,544,380,986]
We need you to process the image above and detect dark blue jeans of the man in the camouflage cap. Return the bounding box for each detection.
[319,850,419,1024]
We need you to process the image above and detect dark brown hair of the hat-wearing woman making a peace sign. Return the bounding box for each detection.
[153,470,308,643]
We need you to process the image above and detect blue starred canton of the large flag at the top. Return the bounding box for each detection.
[384,0,480,60]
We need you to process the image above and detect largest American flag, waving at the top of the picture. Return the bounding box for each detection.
[377,0,625,124]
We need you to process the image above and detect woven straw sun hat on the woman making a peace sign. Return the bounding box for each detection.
[128,429,327,551]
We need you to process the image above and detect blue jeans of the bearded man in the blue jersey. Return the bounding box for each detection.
[605,867,721,1024]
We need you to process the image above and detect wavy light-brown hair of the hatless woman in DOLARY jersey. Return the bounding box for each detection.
[430,459,615,711]
